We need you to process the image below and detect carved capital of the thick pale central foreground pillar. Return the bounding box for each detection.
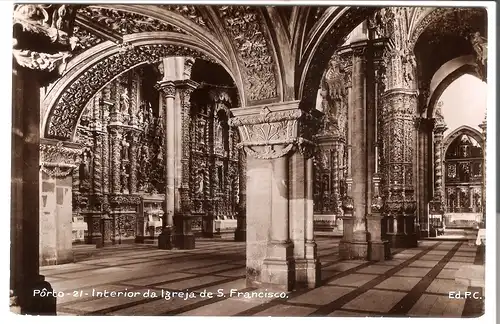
[229,101,320,159]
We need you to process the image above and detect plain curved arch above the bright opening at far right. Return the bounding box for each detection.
[426,56,480,118]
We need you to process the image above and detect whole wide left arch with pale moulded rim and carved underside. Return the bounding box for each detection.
[42,32,240,140]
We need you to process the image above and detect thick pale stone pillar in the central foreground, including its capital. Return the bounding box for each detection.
[230,102,319,290]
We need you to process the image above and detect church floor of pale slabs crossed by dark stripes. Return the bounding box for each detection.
[41,237,484,317]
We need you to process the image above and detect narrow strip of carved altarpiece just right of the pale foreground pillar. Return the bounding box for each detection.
[313,53,351,231]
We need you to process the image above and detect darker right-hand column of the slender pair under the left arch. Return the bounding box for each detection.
[174,80,198,250]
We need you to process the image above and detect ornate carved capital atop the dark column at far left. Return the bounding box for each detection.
[12,4,78,83]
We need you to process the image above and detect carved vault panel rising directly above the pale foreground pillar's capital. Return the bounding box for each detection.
[217,6,278,101]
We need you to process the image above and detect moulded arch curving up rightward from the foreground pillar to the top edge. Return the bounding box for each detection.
[295,7,378,110]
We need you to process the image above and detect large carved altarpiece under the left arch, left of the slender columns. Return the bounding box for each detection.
[73,69,165,246]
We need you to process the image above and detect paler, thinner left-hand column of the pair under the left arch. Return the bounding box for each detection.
[157,78,176,249]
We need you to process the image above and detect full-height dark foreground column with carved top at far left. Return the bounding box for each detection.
[10,4,78,315]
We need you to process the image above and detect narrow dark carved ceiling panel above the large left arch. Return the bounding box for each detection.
[78,6,185,35]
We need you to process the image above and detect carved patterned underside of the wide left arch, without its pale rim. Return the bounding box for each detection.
[45,44,213,140]
